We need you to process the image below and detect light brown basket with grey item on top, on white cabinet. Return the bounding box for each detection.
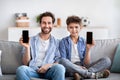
[15,13,30,27]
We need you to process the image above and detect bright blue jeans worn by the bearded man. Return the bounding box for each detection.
[16,64,65,80]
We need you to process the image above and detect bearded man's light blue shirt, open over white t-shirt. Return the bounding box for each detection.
[22,34,60,70]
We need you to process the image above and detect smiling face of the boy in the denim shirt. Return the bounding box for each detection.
[67,23,82,37]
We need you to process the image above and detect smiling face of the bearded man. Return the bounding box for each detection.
[40,16,53,34]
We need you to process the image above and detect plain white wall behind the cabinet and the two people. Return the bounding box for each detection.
[0,0,120,40]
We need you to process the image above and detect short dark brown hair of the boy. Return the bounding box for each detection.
[66,16,82,25]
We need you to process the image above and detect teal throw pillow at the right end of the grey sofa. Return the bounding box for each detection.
[111,43,120,73]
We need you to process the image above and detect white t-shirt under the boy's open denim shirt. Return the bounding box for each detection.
[71,42,80,63]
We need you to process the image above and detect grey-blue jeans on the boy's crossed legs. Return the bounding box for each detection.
[59,57,111,78]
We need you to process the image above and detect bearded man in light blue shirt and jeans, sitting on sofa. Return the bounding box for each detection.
[16,12,65,80]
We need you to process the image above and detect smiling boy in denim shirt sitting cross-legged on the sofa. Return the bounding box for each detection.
[59,16,111,80]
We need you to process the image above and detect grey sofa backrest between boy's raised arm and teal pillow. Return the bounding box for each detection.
[91,39,120,62]
